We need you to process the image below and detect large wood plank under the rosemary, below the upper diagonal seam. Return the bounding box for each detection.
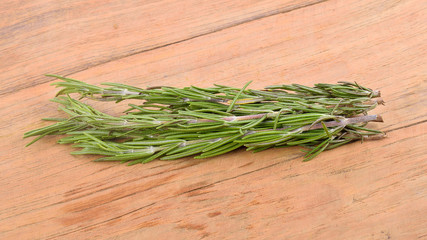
[0,1,427,239]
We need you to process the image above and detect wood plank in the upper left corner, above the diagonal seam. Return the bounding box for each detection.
[0,0,324,94]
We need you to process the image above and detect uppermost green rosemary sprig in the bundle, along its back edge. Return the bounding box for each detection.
[49,75,383,116]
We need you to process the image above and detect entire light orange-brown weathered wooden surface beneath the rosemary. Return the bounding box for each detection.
[0,0,427,239]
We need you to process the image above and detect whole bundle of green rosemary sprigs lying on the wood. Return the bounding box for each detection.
[24,75,385,165]
